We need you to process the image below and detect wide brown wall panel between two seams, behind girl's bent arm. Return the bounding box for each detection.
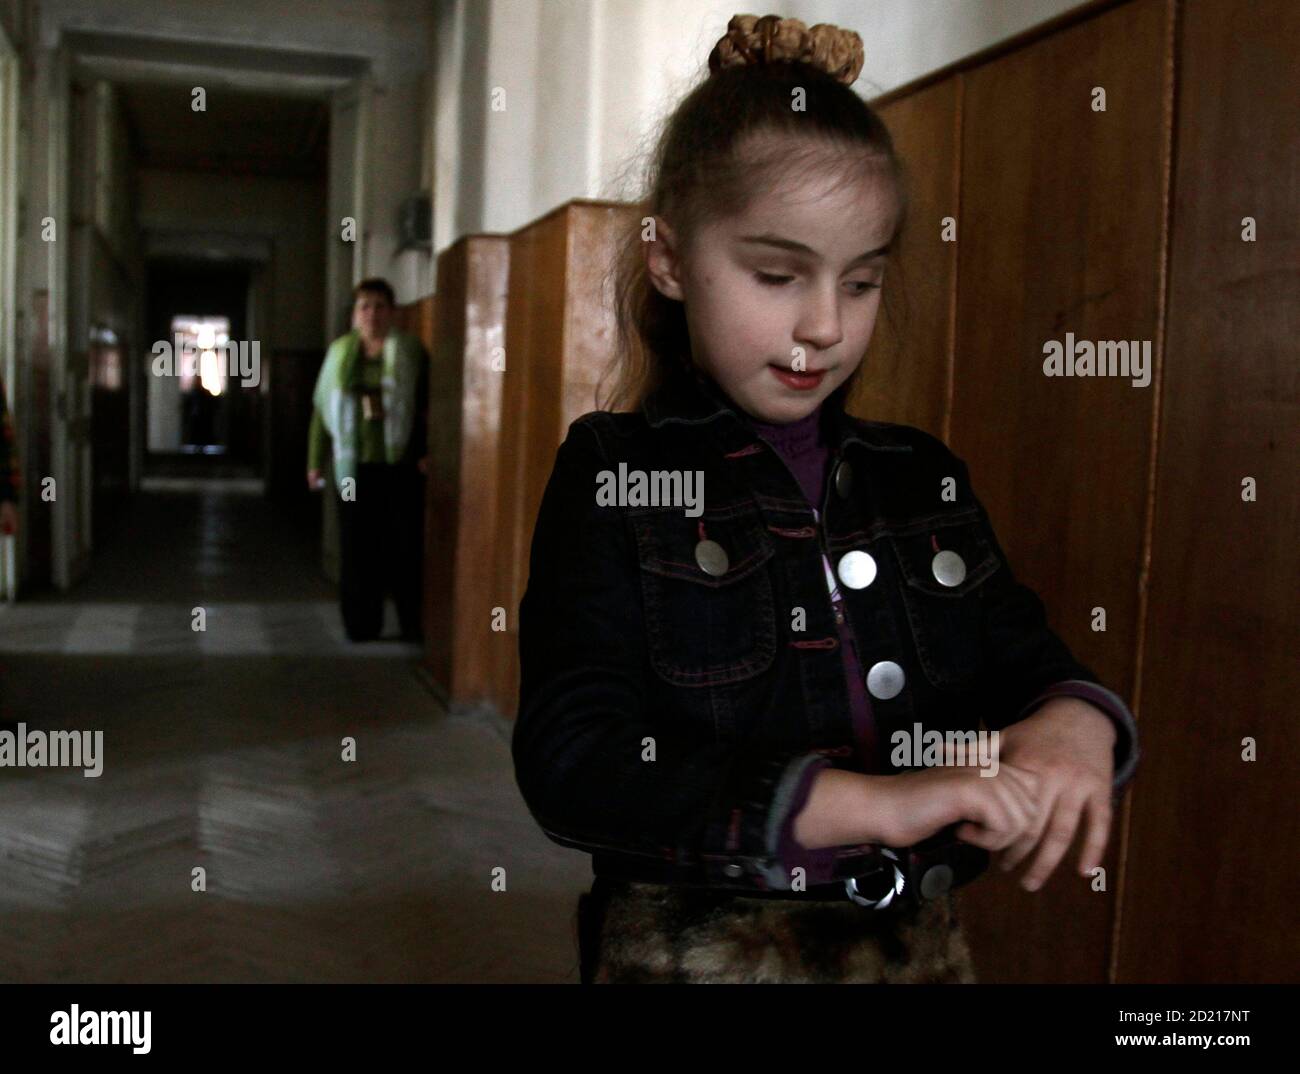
[949,0,1174,982]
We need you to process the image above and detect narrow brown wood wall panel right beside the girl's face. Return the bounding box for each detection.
[848,75,962,438]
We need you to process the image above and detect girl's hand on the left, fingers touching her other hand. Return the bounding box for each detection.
[881,761,1039,850]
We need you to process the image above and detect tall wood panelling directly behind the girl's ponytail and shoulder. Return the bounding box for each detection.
[494,200,632,719]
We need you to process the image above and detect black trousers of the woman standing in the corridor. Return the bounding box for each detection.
[338,463,424,641]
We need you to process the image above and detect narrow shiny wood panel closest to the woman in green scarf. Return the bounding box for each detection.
[424,235,510,710]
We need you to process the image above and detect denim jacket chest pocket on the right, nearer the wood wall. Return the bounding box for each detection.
[885,508,1001,689]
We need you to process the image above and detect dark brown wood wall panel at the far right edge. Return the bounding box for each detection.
[1117,0,1300,983]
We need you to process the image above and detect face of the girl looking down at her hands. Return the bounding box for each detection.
[646,151,898,425]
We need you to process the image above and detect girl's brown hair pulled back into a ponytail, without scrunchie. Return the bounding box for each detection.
[597,46,909,410]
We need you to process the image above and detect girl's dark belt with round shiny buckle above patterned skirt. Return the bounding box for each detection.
[597,824,989,914]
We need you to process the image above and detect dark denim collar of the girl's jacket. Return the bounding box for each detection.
[641,358,911,452]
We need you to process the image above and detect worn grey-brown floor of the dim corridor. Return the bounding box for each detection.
[0,482,590,982]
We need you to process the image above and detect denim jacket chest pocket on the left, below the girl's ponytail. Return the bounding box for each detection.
[629,503,776,687]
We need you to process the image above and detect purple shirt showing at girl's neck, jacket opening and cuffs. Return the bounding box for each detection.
[745,406,1131,885]
